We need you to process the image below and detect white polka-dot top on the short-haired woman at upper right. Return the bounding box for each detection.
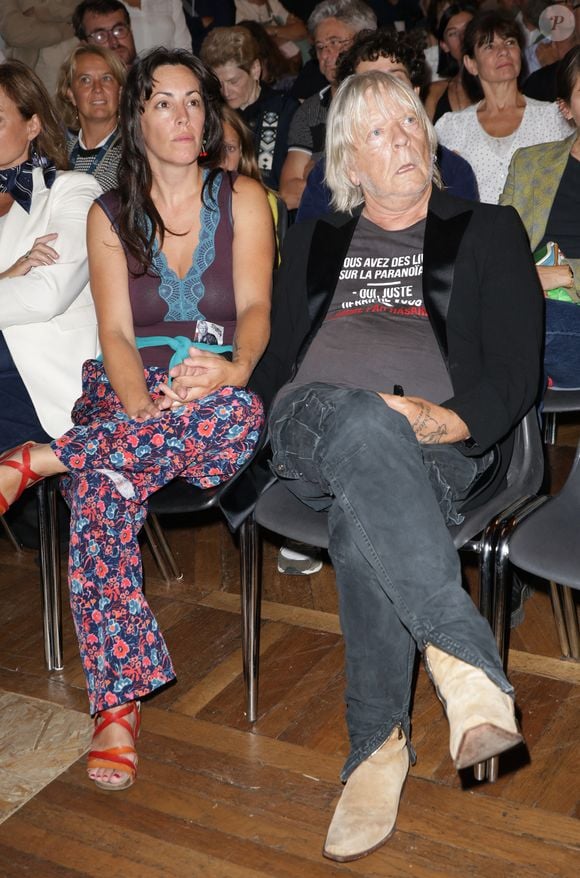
[435,98,572,204]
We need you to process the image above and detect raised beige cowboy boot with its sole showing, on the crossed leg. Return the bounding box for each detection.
[424,644,523,769]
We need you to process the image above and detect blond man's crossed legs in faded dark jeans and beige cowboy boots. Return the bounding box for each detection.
[270,383,521,860]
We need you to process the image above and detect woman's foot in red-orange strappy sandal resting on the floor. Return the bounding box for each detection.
[87,701,140,790]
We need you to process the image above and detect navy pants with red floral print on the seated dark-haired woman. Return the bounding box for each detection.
[51,360,264,714]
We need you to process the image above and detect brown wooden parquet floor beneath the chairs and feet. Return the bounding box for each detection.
[0,439,580,878]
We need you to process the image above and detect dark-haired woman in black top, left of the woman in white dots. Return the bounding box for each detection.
[425,2,475,123]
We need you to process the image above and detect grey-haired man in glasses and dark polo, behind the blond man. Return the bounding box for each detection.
[280,0,377,210]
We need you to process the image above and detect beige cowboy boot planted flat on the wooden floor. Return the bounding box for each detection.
[322,726,409,863]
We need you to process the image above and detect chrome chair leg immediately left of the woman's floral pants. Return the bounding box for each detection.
[36,479,64,671]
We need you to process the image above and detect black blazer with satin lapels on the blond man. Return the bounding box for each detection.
[224,188,543,514]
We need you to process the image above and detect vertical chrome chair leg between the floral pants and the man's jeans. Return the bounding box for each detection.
[240,515,262,723]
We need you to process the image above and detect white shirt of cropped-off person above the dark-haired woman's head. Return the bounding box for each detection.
[125,0,191,54]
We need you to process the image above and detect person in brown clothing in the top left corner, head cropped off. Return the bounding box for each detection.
[0,0,76,96]
